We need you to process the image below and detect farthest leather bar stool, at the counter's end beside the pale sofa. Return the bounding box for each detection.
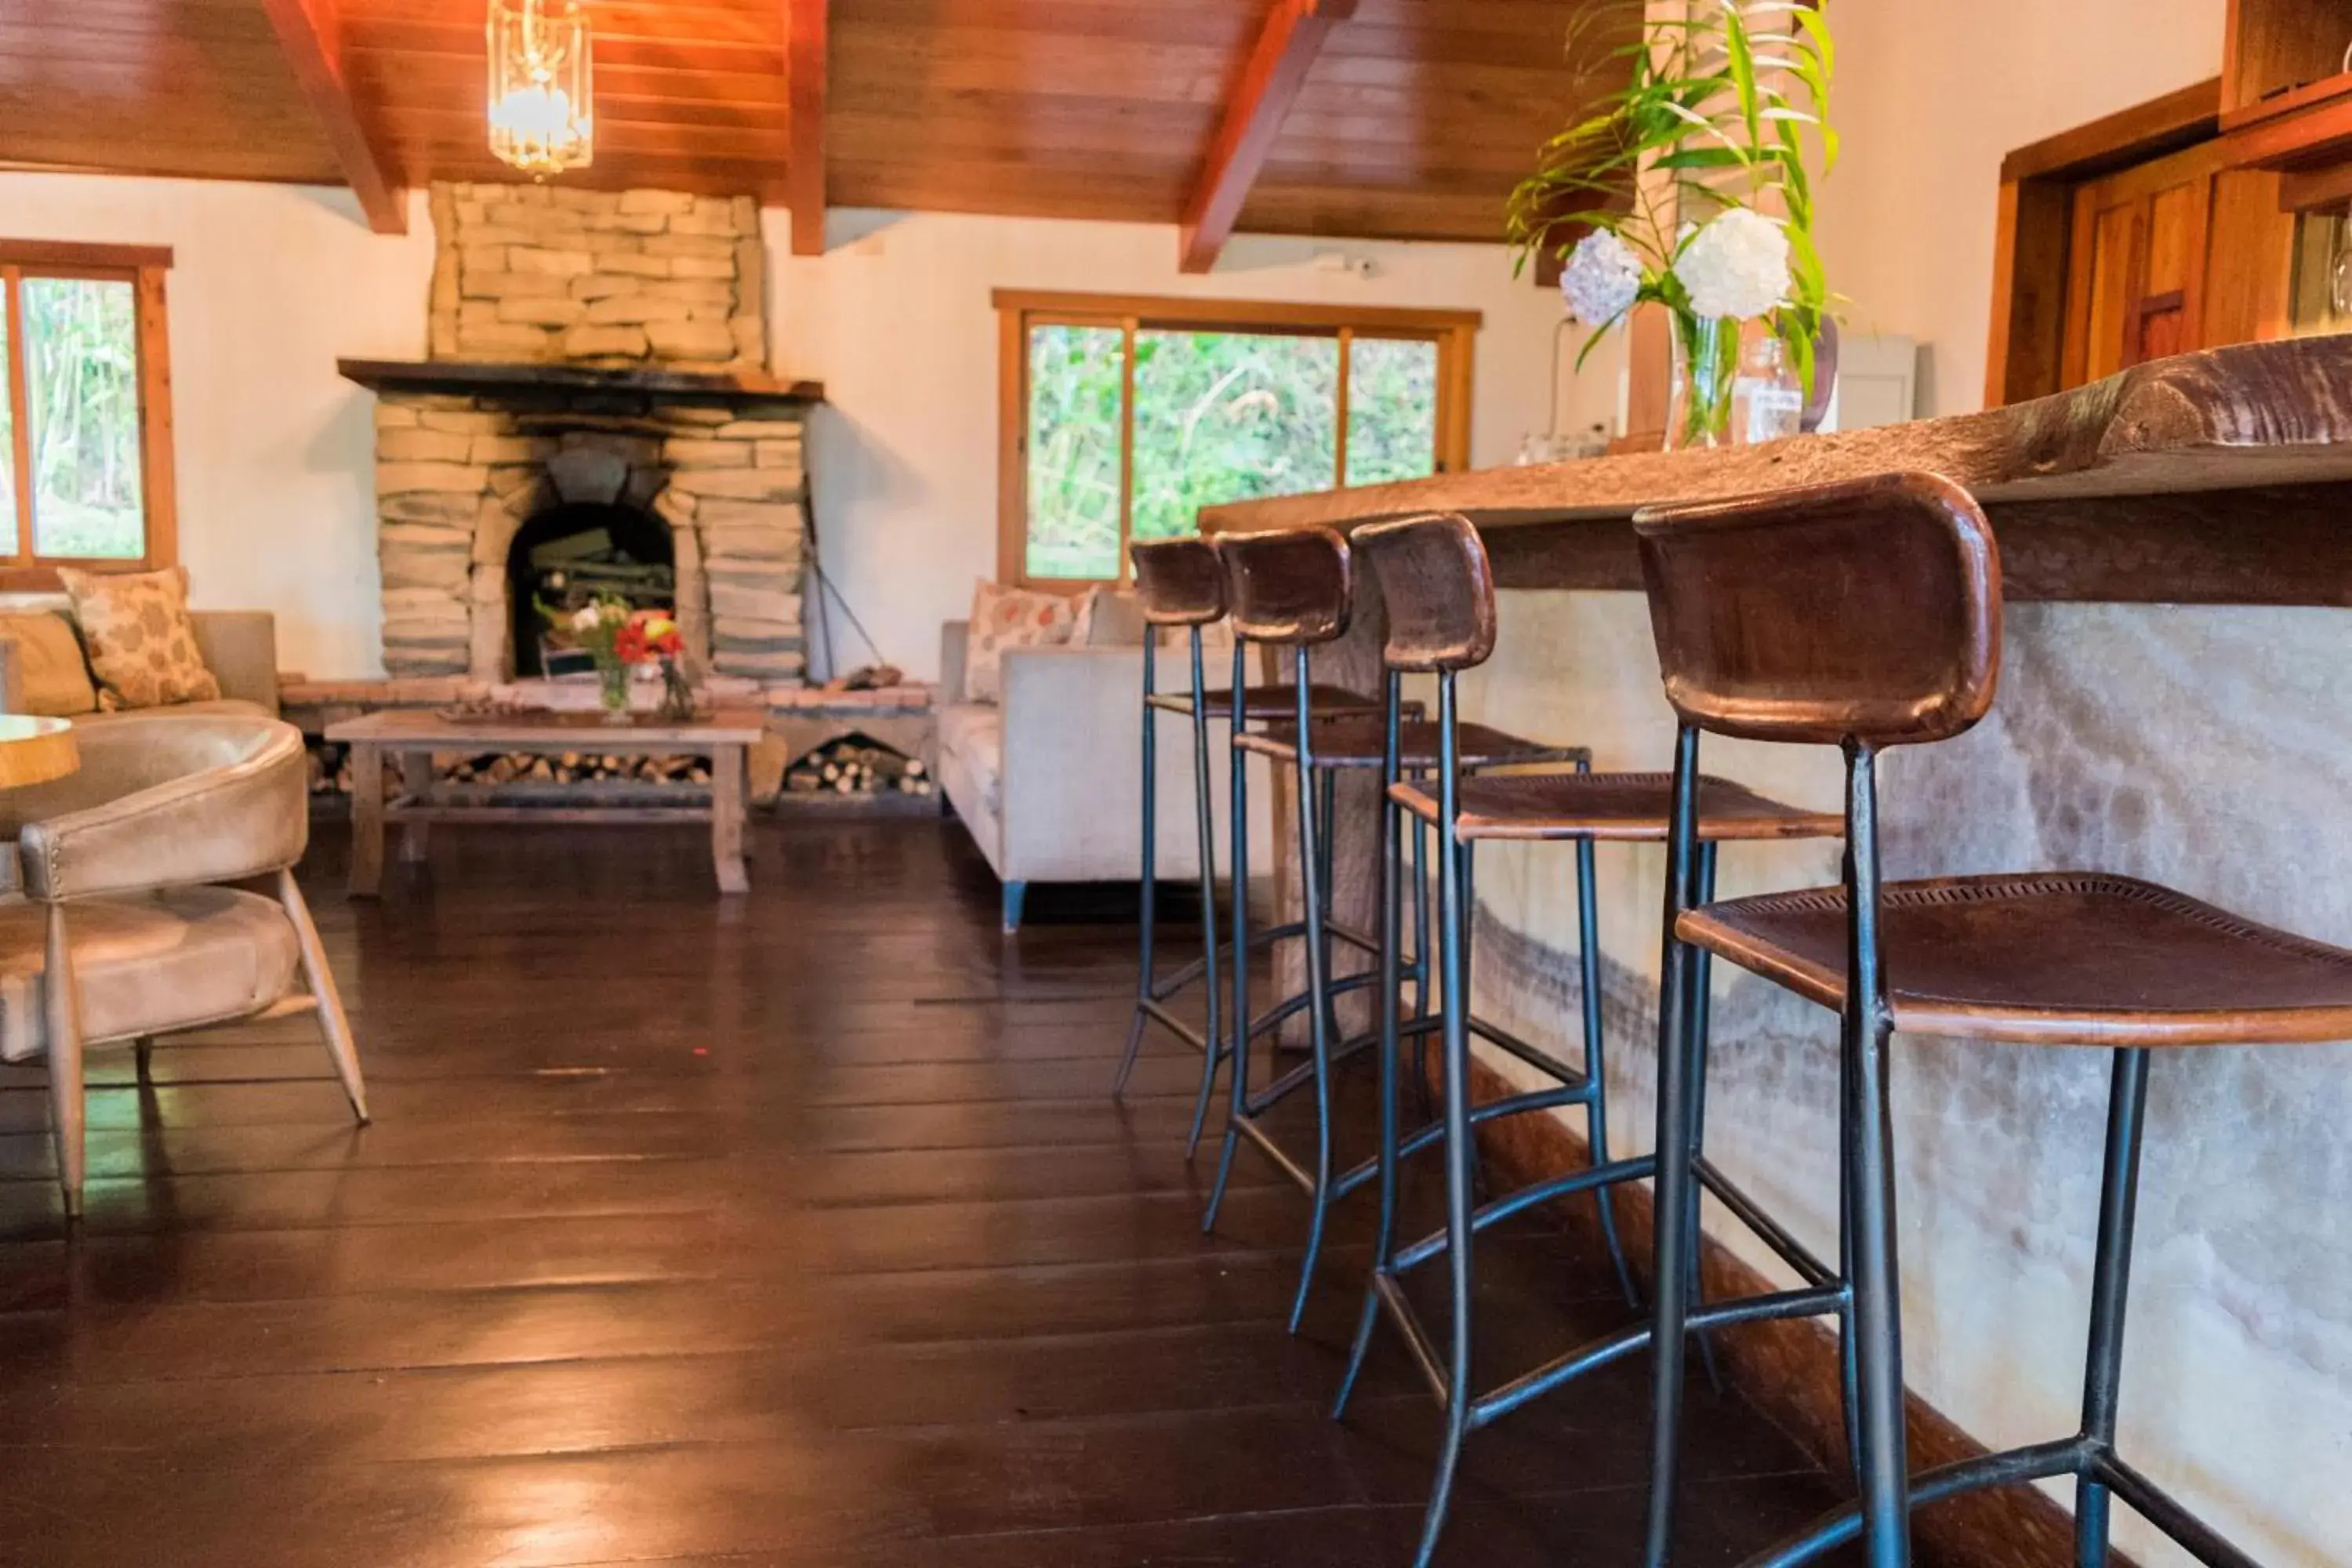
[1110,539,1381,1154]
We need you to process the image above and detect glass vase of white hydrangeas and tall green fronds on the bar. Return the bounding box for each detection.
[1510,0,1837,447]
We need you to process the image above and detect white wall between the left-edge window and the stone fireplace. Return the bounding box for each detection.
[0,174,433,677]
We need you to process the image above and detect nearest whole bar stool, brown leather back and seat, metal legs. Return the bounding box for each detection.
[1635,475,2352,1568]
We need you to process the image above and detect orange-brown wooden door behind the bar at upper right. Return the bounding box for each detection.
[2063,143,2223,386]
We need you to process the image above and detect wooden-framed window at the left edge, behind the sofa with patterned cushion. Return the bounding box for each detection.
[0,240,176,586]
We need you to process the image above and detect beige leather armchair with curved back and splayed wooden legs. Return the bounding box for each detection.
[0,713,367,1213]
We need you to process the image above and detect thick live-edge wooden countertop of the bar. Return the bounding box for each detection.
[1202,334,2352,607]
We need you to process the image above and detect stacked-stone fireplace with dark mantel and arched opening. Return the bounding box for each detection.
[343,186,821,687]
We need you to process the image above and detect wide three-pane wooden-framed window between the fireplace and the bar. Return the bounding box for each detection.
[995,292,1482,588]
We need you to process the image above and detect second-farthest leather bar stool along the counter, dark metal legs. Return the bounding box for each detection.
[1204,529,1585,1333]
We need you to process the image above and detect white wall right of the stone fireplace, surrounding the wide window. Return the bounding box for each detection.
[769,212,1559,677]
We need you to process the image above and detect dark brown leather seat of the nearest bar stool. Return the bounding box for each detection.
[1677,872,2352,1046]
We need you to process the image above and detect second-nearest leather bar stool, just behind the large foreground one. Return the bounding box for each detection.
[1334,517,1842,1563]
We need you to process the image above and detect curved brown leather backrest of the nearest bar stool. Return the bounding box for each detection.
[1637,473,2002,748]
